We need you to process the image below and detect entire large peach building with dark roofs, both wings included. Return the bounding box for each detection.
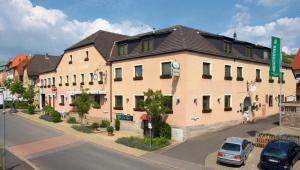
[41,26,296,139]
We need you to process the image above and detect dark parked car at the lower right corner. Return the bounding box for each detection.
[259,140,300,170]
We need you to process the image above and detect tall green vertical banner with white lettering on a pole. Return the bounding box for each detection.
[270,36,281,77]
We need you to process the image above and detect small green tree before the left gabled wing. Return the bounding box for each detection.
[75,90,91,124]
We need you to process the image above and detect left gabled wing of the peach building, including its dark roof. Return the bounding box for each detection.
[40,31,126,119]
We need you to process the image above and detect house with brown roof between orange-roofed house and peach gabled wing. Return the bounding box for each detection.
[23,54,61,104]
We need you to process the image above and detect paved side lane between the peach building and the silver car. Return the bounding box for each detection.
[161,115,278,165]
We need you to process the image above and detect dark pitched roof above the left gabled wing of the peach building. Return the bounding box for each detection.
[65,30,128,59]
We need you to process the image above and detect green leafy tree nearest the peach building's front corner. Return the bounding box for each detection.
[140,89,170,137]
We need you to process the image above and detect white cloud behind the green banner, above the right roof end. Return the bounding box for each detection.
[223,17,300,54]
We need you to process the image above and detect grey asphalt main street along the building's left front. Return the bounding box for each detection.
[0,114,171,170]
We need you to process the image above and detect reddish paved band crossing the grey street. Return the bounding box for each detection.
[8,135,80,157]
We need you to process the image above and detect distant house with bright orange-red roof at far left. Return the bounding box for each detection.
[6,54,31,81]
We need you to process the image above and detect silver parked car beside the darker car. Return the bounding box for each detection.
[217,137,254,165]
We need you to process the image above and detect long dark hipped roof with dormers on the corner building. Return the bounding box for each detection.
[109,25,289,67]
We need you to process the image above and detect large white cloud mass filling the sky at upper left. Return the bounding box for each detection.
[0,0,151,59]
